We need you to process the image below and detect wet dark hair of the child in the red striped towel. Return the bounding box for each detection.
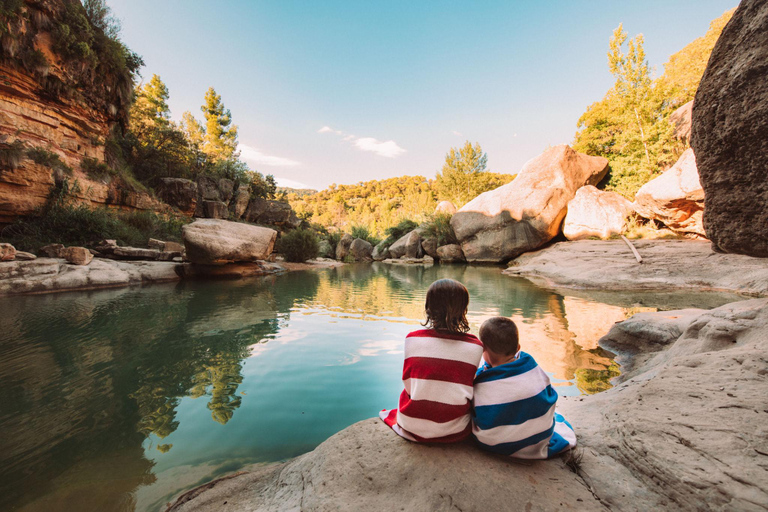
[423,279,469,333]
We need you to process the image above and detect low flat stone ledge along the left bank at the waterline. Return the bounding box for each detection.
[0,258,180,295]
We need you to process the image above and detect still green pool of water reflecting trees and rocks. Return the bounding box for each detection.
[0,264,734,512]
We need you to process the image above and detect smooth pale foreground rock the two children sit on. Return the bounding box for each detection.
[167,299,768,512]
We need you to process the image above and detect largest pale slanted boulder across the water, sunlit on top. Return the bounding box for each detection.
[451,145,608,262]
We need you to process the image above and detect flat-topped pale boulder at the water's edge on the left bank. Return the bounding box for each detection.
[182,219,277,264]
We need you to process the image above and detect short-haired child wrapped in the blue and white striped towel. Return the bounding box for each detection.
[472,317,576,459]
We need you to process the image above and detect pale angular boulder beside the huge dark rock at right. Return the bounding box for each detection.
[632,148,705,236]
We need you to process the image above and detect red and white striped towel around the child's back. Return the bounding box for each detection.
[379,329,483,443]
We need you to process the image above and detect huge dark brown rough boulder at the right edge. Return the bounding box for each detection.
[691,0,768,257]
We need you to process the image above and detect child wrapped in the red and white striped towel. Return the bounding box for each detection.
[379,279,483,443]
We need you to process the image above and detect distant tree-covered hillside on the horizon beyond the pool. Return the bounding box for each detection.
[286,172,514,237]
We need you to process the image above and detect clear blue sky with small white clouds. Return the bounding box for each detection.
[108,0,737,188]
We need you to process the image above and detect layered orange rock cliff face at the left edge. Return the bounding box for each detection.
[0,0,163,225]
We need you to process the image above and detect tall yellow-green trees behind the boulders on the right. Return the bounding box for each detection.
[573,11,732,199]
